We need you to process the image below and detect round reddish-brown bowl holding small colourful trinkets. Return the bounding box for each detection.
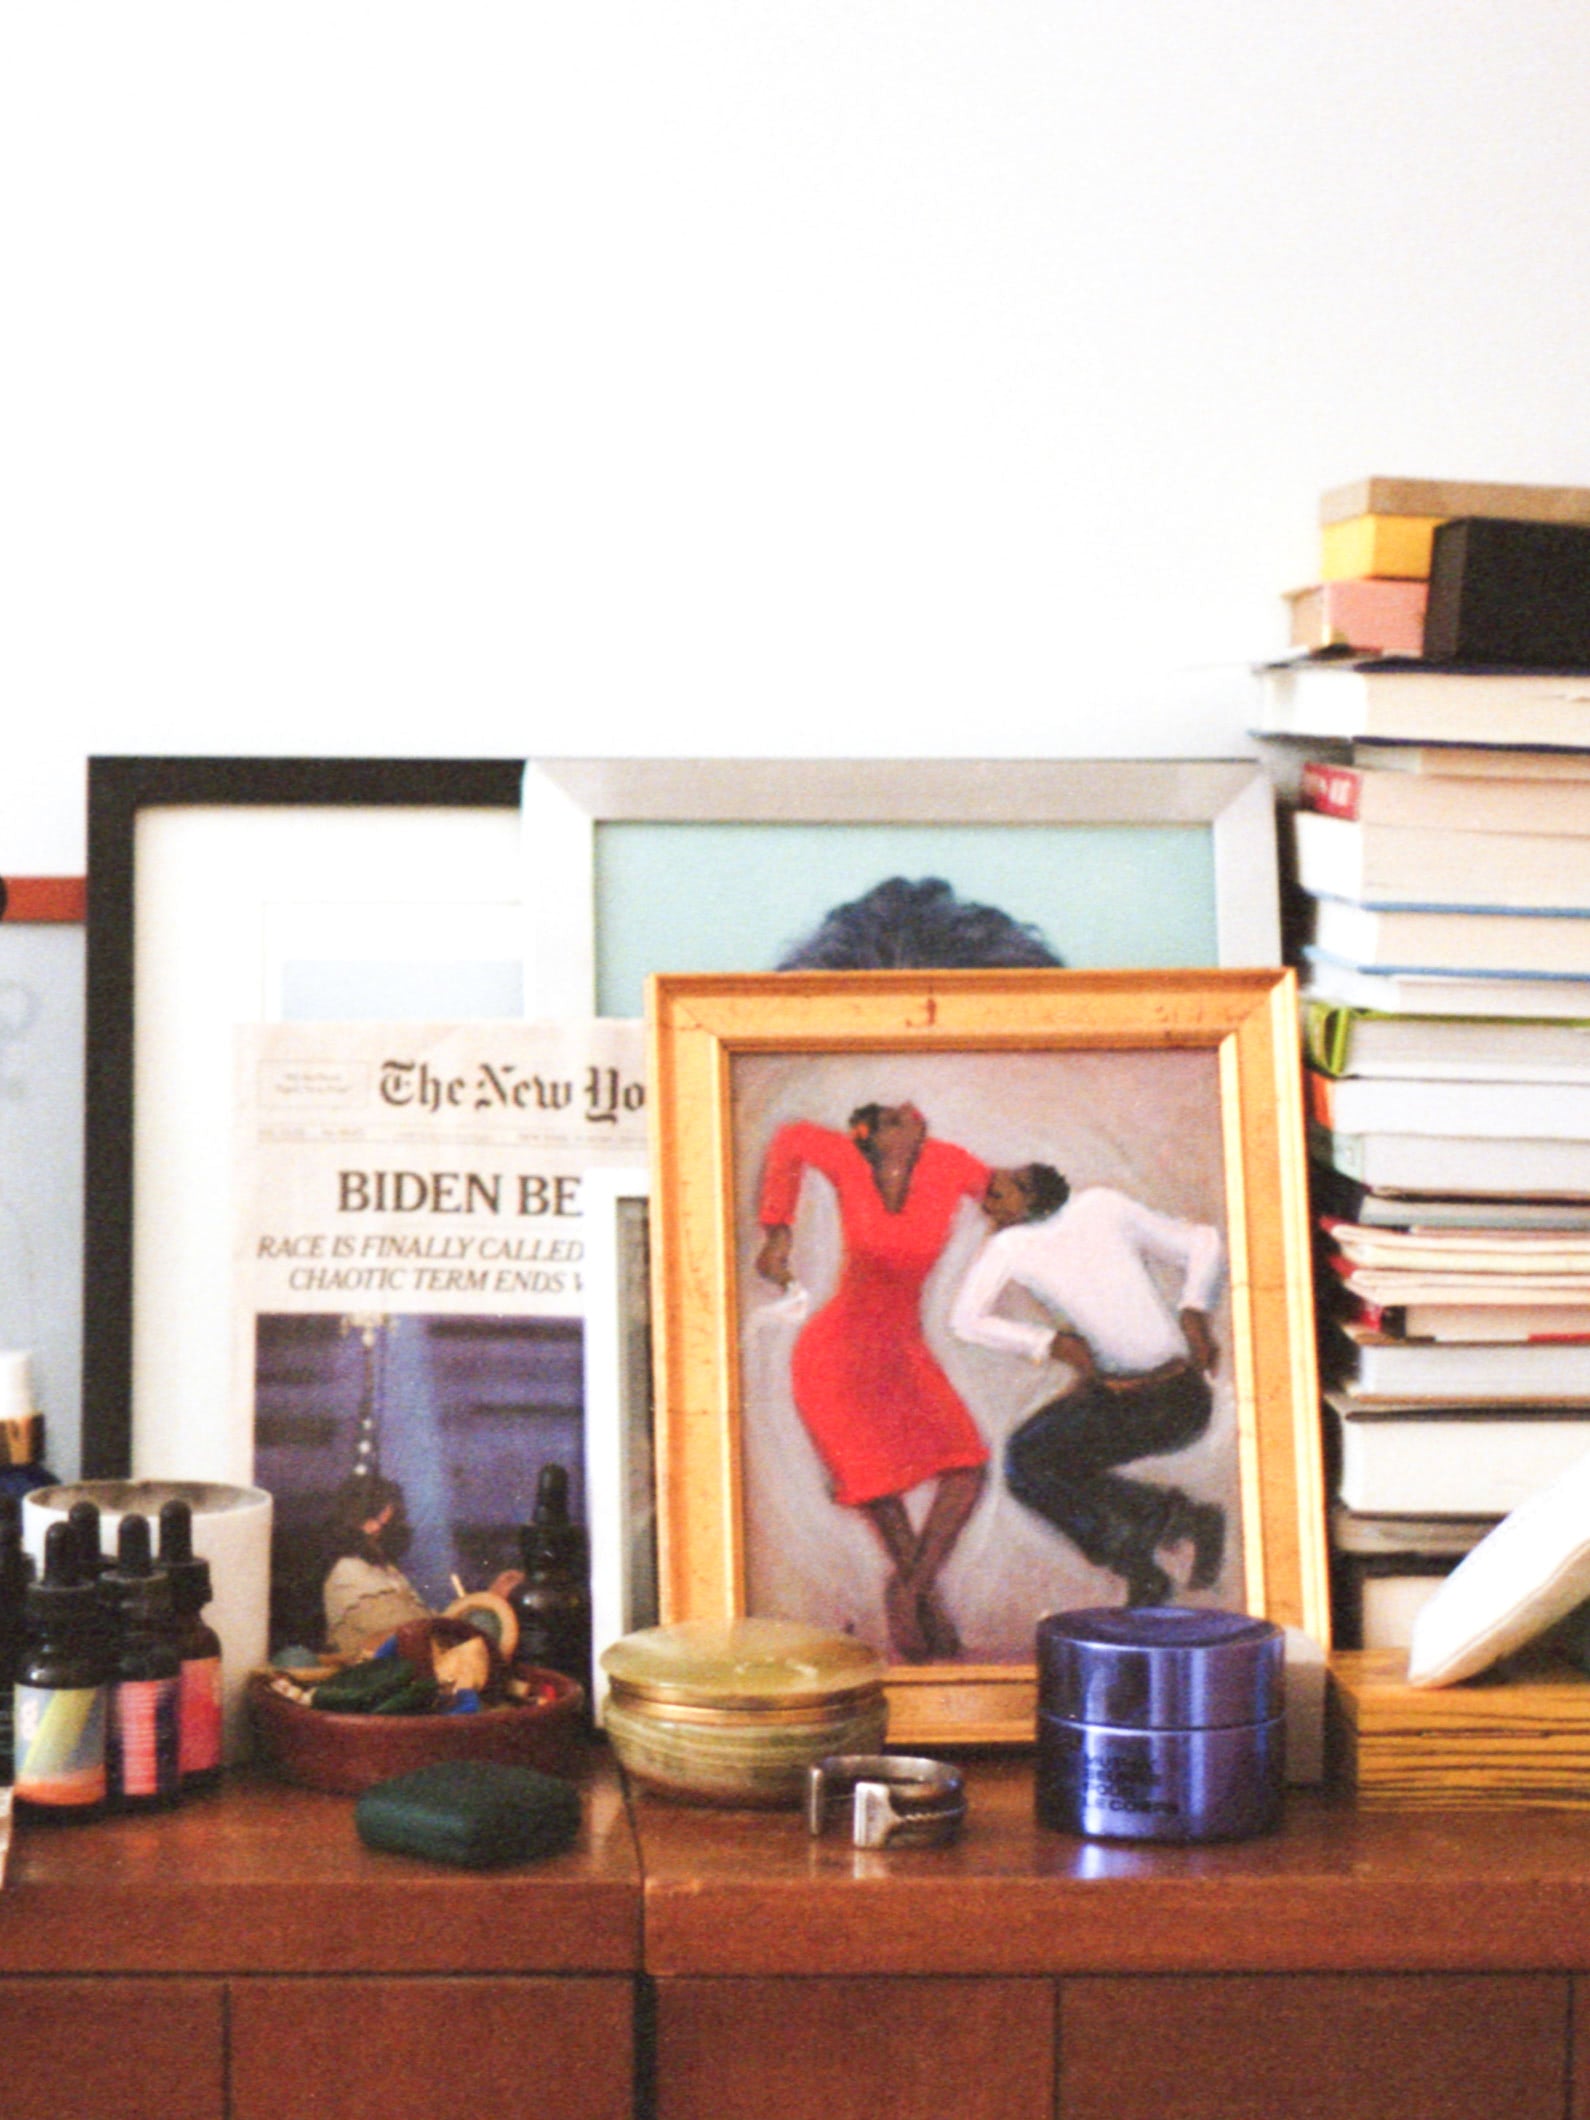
[248,1671,585,1796]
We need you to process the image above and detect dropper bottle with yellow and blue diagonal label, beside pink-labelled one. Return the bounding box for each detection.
[15,1518,110,1819]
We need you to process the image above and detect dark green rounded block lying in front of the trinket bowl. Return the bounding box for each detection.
[354,1760,581,1870]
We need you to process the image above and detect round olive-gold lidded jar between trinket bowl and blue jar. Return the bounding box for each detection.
[602,1620,888,1808]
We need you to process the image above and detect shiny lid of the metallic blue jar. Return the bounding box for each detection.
[1039,1605,1287,1730]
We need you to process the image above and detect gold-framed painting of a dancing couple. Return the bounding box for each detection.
[649,969,1329,1743]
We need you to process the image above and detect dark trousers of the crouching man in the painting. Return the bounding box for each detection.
[1005,1367,1213,1573]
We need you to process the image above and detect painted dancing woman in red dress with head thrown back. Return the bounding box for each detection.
[757,1105,992,1662]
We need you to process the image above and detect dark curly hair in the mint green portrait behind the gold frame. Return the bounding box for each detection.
[778,876,1064,971]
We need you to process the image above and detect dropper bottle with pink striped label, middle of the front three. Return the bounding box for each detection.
[100,1516,182,1810]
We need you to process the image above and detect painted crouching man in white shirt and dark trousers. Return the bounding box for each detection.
[950,1164,1225,1605]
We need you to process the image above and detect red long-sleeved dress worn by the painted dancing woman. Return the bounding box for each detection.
[759,1119,988,1505]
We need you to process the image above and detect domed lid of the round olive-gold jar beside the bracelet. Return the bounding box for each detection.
[602,1618,886,1711]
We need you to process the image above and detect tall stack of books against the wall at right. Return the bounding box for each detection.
[1257,479,1590,1647]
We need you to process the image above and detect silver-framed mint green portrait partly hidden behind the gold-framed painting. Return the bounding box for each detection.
[519,759,1280,1015]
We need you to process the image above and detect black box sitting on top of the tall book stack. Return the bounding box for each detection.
[1425,515,1590,670]
